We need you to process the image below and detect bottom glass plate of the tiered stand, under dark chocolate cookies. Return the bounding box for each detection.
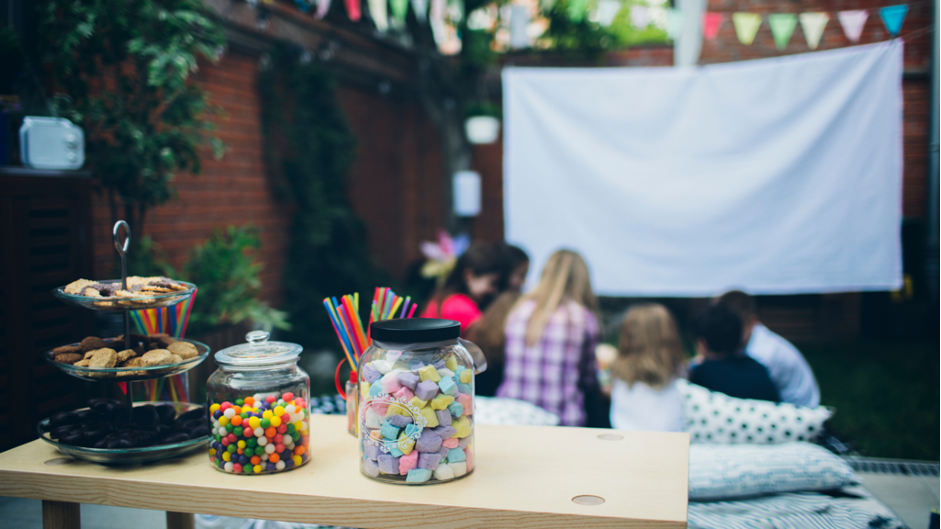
[36,401,210,465]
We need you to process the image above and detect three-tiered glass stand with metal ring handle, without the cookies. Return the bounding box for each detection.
[38,220,210,463]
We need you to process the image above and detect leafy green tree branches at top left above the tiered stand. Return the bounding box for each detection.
[37,0,225,235]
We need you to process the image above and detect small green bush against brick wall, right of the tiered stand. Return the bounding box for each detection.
[183,226,291,334]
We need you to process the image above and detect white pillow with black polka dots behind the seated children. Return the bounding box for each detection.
[677,380,833,444]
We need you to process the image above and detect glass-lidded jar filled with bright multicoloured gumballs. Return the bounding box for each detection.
[206,331,310,474]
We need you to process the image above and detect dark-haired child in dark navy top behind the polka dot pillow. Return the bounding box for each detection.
[689,304,781,402]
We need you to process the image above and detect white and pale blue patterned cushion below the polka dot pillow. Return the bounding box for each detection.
[689,443,857,501]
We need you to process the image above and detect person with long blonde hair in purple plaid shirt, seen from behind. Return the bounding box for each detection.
[497,250,600,426]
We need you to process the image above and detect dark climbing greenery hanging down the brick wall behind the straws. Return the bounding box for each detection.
[258,49,388,348]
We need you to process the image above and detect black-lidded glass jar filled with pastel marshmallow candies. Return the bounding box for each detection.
[358,318,474,485]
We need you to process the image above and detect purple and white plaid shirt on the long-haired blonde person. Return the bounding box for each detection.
[497,301,600,426]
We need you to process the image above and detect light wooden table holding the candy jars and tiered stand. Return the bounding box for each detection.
[0,415,689,529]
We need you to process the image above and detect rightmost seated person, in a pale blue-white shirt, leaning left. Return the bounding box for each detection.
[716,290,820,407]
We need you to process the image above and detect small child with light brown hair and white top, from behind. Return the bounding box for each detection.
[611,303,685,432]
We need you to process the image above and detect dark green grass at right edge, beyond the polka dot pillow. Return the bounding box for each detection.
[801,342,941,461]
